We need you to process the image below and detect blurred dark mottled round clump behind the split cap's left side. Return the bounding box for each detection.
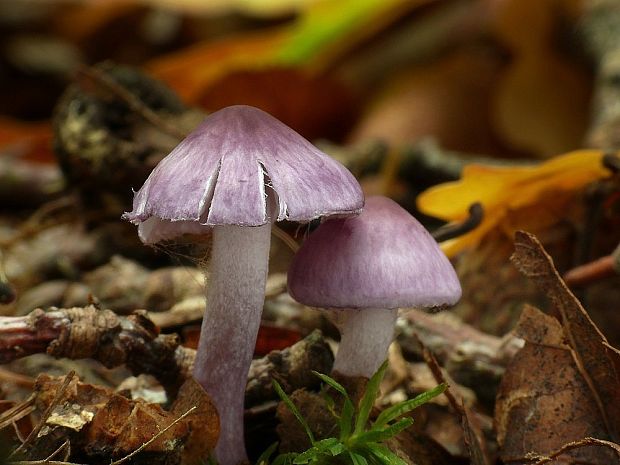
[53,62,204,218]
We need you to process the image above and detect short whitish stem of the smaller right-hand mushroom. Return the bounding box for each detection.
[331,308,398,378]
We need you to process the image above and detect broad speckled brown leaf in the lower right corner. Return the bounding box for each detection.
[495,306,617,465]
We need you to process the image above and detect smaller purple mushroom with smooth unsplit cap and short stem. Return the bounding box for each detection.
[288,197,461,378]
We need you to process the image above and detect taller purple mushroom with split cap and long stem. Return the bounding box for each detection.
[124,105,364,465]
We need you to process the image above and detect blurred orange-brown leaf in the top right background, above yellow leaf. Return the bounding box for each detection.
[491,0,592,158]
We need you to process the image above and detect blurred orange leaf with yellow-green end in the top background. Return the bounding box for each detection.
[148,0,435,103]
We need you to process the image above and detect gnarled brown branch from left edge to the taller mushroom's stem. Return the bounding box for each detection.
[0,305,194,394]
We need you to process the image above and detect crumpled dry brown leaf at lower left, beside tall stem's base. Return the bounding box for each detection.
[34,375,219,463]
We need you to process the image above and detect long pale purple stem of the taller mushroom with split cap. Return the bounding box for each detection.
[194,223,271,465]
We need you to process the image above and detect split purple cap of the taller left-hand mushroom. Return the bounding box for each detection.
[124,105,364,243]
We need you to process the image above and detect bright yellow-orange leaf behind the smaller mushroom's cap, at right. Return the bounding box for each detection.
[418,150,609,256]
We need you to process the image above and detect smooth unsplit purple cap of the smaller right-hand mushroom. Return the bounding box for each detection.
[288,197,461,308]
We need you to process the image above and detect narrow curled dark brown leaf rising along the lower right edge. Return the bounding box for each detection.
[511,231,620,442]
